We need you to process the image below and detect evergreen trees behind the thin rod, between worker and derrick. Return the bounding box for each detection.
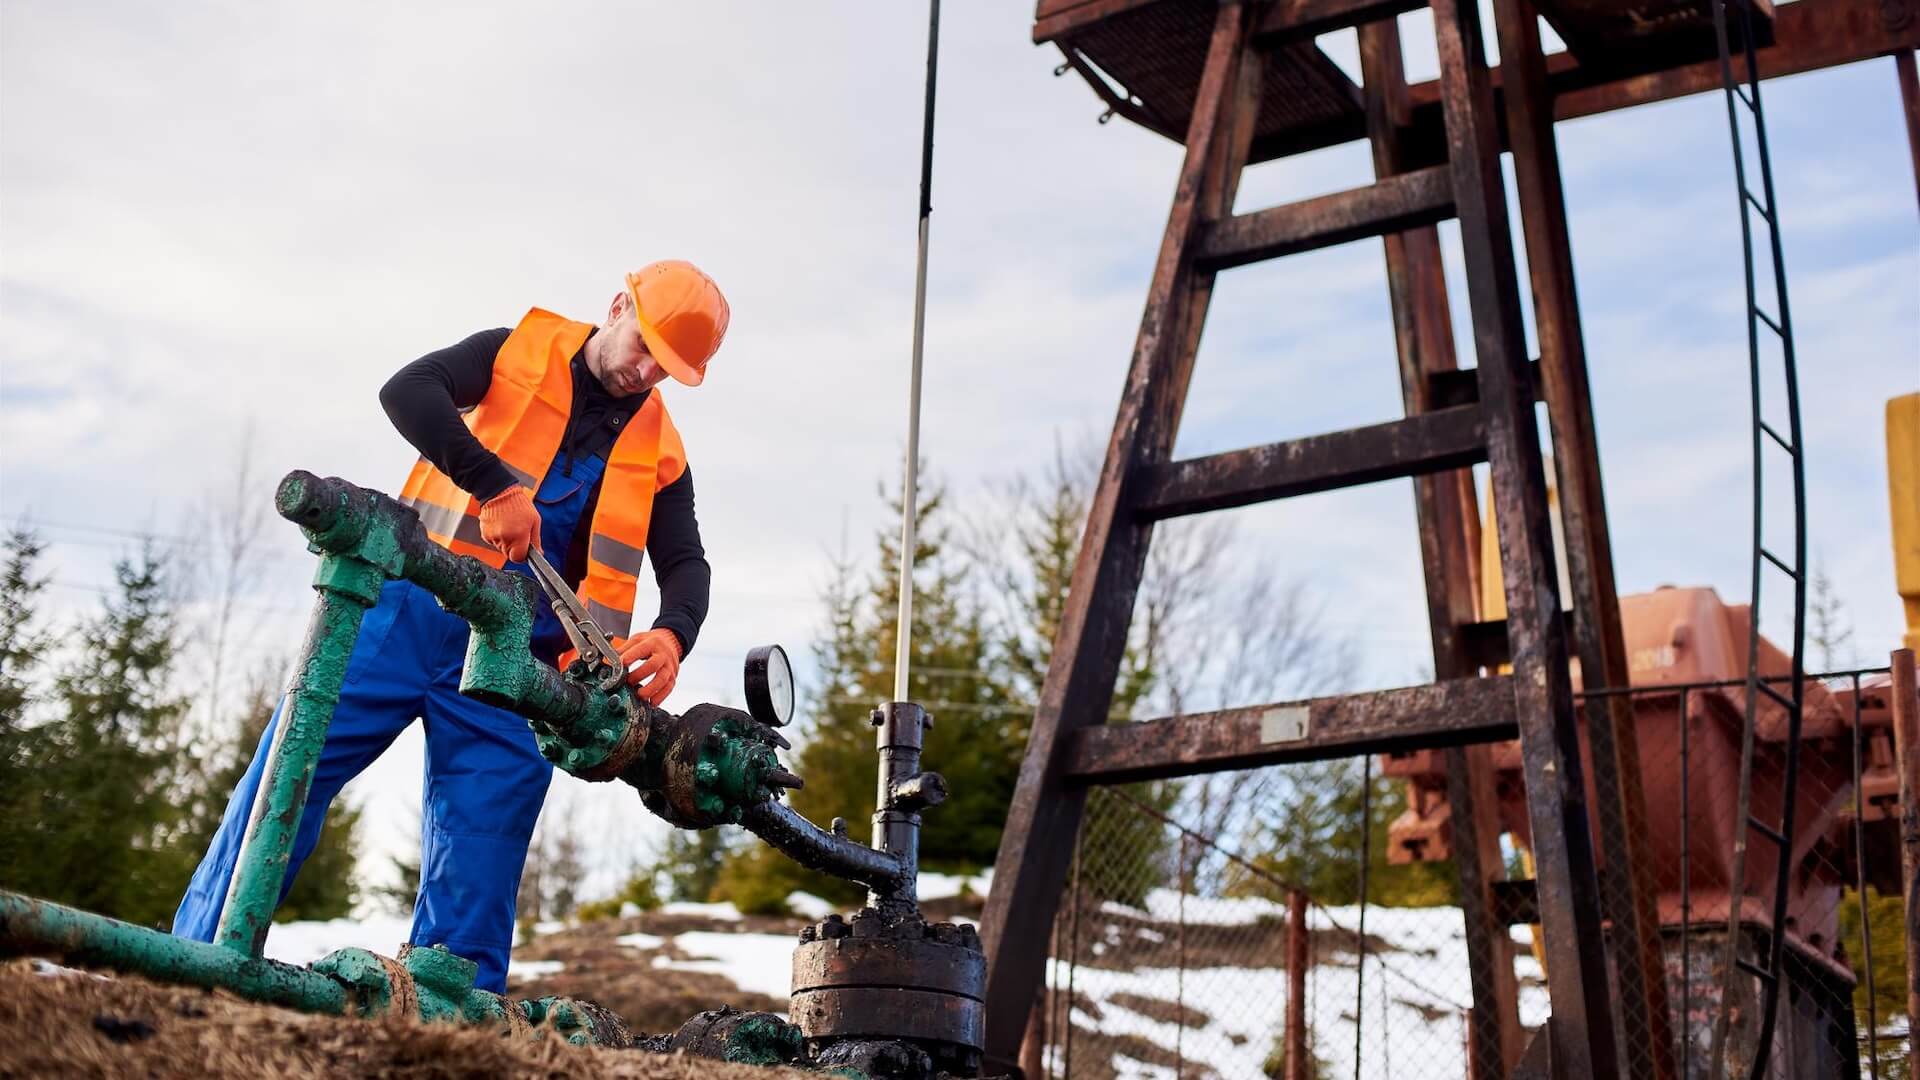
[714,457,1177,913]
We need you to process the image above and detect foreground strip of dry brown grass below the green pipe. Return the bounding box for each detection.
[0,961,804,1080]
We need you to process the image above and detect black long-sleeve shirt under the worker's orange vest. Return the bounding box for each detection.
[380,329,712,657]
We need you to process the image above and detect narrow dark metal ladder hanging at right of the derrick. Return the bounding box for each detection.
[1711,0,1807,1080]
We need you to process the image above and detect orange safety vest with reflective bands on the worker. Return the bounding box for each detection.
[399,307,687,638]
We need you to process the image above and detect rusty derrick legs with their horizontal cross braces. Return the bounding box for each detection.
[983,0,1670,1076]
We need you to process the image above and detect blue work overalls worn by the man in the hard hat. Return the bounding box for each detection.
[173,450,607,994]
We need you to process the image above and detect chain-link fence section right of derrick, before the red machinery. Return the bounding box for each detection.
[1582,669,1910,1080]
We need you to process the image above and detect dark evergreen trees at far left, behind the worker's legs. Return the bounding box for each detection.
[0,530,357,926]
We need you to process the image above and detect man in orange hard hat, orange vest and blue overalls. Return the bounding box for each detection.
[173,261,728,992]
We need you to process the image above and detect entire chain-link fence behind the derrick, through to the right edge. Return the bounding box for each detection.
[1027,671,1912,1080]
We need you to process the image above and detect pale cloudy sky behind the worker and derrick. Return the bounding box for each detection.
[0,0,1920,883]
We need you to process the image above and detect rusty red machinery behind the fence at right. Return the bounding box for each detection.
[1380,586,1899,968]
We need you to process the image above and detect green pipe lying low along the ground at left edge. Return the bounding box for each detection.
[0,890,348,1013]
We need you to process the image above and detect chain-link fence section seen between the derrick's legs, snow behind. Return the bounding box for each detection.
[1037,759,1520,1080]
